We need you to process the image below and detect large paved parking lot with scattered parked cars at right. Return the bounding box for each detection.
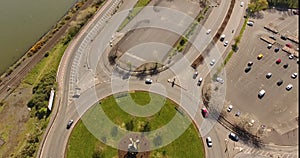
[225,11,299,143]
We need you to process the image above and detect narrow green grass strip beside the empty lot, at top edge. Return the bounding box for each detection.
[118,0,151,31]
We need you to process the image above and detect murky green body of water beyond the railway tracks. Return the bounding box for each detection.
[0,0,77,74]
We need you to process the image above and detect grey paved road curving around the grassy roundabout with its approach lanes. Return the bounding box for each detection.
[39,0,250,158]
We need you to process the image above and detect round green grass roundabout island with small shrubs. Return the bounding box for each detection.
[66,91,205,158]
